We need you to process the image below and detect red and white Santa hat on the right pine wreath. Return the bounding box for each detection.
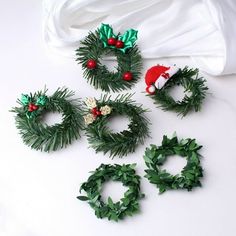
[145,65,179,94]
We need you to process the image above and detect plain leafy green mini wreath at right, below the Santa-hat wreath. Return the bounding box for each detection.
[144,136,203,193]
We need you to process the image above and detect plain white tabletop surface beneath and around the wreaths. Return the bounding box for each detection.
[0,0,236,236]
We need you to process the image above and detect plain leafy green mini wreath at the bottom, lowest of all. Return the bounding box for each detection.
[77,164,144,221]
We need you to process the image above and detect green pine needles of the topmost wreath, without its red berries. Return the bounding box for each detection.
[76,23,142,92]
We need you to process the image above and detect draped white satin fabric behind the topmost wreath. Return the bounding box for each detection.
[44,0,236,75]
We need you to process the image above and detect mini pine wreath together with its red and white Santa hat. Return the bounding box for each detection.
[145,65,208,116]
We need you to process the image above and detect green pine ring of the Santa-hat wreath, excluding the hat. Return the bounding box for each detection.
[148,67,208,116]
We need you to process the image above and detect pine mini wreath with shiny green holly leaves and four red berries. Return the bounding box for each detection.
[76,24,142,92]
